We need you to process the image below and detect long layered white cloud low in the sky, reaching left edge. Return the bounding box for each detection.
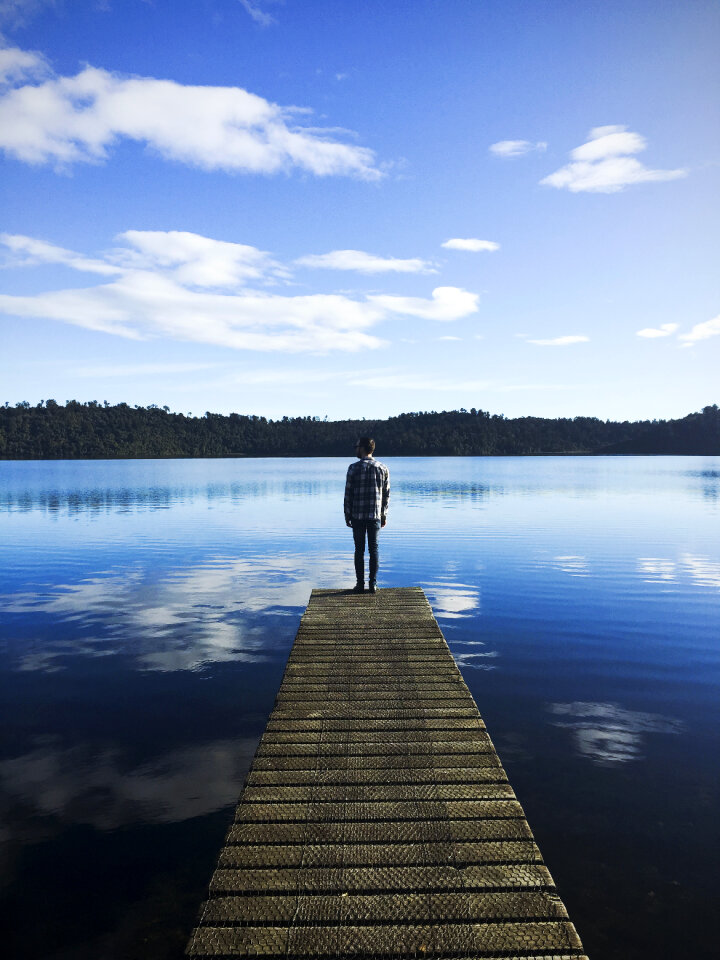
[0,230,478,353]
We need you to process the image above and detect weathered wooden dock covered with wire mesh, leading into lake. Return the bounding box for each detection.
[187,588,587,960]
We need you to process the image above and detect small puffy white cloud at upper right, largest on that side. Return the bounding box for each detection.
[540,125,687,193]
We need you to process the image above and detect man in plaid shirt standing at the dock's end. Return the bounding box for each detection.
[345,437,390,593]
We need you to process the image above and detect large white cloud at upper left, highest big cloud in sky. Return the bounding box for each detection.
[0,51,381,180]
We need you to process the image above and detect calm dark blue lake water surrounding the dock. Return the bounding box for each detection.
[0,457,720,960]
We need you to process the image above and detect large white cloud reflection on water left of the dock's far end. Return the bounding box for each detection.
[0,553,350,673]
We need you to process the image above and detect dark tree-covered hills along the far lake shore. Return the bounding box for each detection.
[0,400,720,460]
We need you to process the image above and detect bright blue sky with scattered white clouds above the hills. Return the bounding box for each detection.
[0,0,720,419]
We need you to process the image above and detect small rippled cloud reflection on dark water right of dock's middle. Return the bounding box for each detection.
[547,701,683,764]
